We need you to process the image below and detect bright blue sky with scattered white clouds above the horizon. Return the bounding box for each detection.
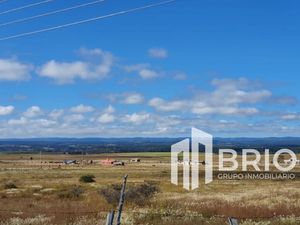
[0,0,300,138]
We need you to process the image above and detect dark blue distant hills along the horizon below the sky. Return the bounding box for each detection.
[0,137,300,154]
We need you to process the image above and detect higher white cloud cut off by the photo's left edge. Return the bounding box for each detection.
[0,59,32,81]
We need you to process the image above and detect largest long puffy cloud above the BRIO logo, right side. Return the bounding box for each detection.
[148,78,272,116]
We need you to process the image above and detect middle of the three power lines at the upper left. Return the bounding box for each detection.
[0,0,105,27]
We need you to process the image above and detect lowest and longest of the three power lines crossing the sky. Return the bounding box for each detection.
[0,0,176,41]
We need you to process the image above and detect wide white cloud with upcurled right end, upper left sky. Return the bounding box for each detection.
[38,49,114,84]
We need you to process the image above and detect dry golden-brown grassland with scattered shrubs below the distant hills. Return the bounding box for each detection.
[0,153,300,225]
